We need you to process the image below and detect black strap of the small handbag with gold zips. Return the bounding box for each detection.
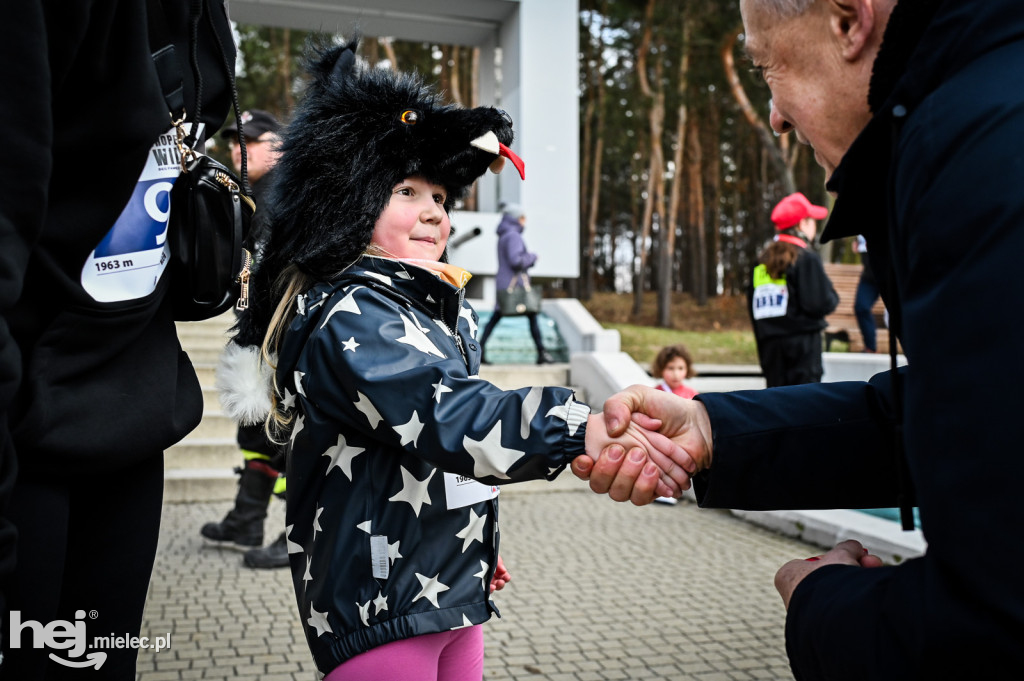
[146,0,252,197]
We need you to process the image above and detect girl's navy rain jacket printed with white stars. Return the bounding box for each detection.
[278,256,590,673]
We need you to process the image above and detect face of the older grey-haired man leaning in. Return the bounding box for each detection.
[739,0,873,177]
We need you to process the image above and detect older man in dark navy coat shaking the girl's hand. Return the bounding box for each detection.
[573,0,1024,680]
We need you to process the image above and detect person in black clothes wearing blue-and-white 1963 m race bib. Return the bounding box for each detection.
[0,0,234,681]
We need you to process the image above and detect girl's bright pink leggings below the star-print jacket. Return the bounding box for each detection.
[324,625,483,681]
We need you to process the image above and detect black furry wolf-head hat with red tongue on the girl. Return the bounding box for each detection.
[224,38,524,419]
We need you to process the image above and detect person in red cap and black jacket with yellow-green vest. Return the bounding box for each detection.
[748,191,839,388]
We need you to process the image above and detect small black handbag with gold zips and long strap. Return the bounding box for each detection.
[147,0,256,322]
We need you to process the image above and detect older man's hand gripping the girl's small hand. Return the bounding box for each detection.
[572,385,712,505]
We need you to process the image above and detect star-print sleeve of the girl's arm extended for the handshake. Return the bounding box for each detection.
[304,289,590,484]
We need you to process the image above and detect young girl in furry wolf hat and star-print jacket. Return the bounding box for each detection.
[220,38,686,681]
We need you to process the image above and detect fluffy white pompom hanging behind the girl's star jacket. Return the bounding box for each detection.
[214,342,273,425]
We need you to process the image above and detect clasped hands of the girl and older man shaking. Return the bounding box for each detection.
[572,385,712,506]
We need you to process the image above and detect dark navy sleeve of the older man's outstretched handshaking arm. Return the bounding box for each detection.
[694,372,898,511]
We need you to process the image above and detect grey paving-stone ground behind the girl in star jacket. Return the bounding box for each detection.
[136,481,820,681]
